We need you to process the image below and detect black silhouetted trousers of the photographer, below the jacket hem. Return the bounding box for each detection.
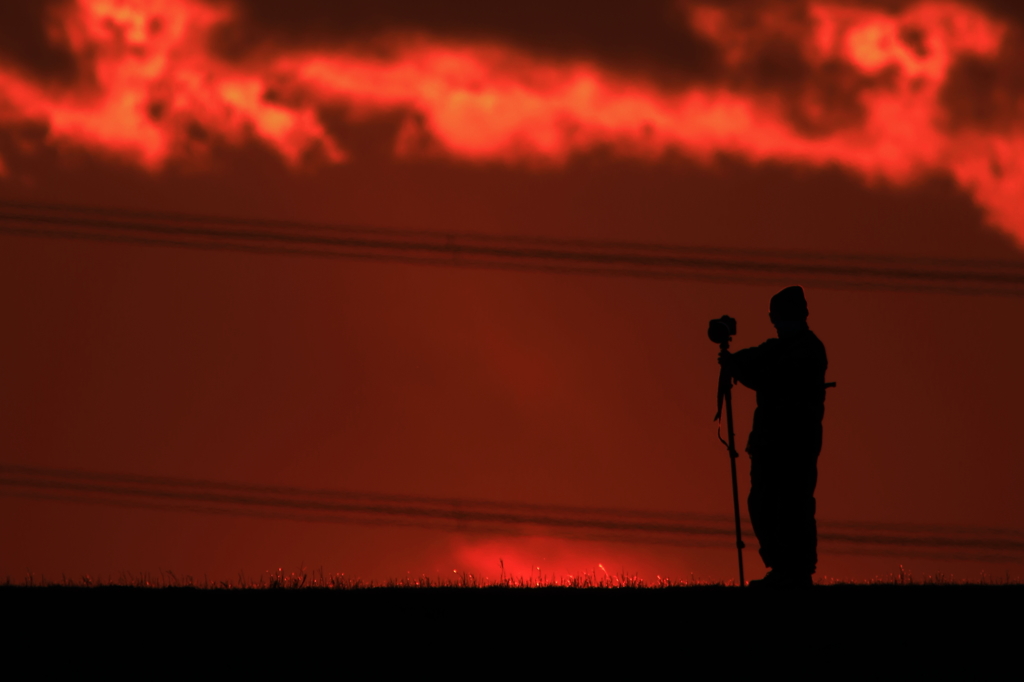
[746,452,818,576]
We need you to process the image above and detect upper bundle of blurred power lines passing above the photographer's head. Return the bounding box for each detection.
[6,202,1024,297]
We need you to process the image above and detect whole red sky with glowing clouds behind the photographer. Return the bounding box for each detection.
[0,0,1024,580]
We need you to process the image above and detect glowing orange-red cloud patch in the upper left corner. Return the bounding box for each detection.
[0,0,343,170]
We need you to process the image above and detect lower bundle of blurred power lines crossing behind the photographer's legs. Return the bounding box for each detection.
[0,465,1024,562]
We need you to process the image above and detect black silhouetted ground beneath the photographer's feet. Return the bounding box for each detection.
[0,584,1024,667]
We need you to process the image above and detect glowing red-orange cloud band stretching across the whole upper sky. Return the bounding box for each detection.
[0,0,1024,242]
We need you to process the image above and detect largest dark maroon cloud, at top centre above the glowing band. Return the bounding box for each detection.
[212,0,716,83]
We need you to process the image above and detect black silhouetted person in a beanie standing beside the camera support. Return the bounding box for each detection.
[720,287,828,587]
